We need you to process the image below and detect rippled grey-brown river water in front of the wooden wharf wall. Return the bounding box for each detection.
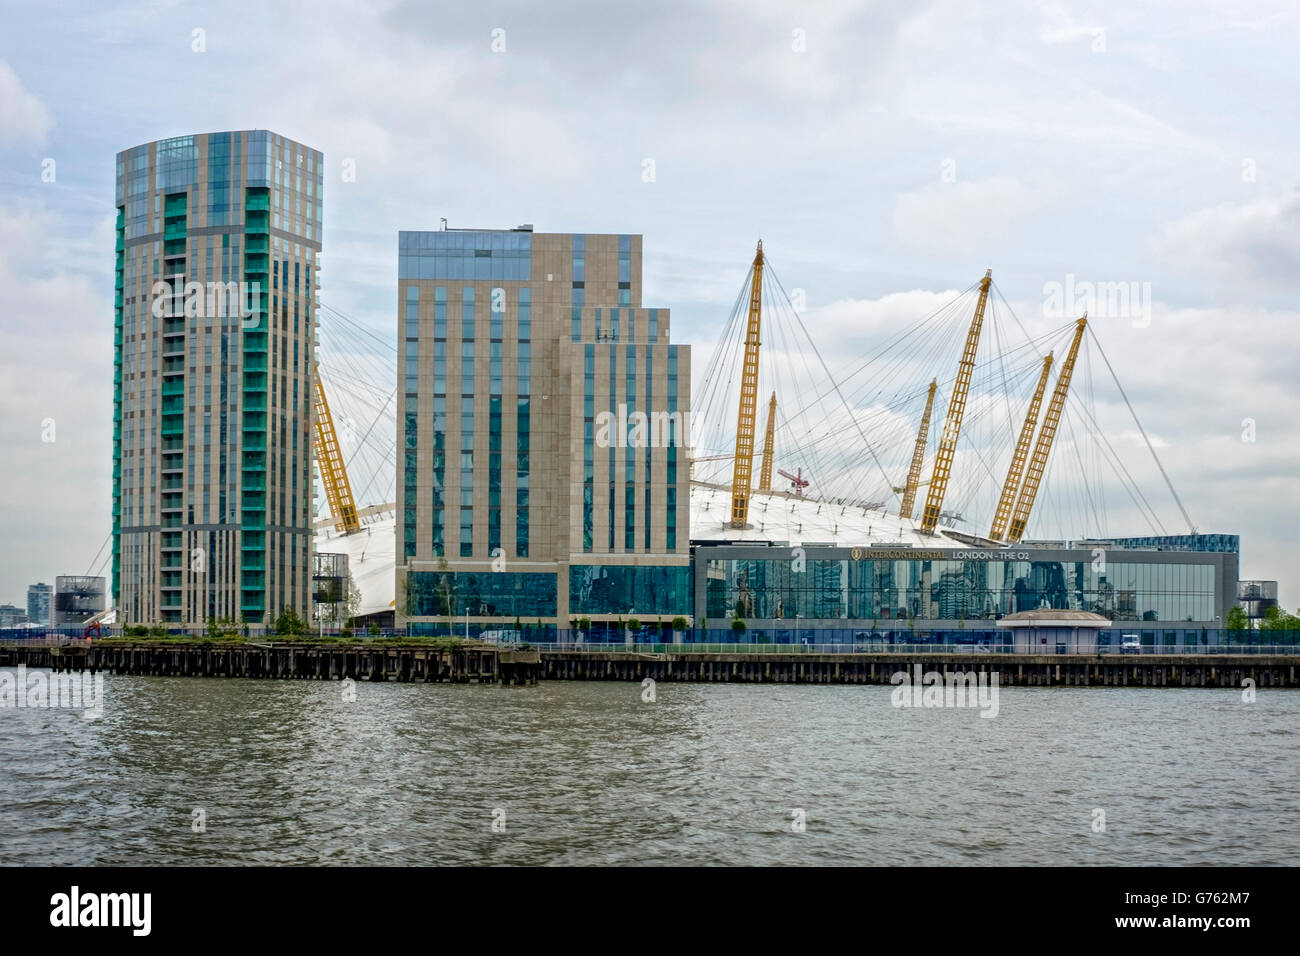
[0,675,1300,865]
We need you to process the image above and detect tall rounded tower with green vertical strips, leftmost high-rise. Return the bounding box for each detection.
[111,130,322,624]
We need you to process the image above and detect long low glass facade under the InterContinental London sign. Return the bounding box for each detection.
[694,545,1238,631]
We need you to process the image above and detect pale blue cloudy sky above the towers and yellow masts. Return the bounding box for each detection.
[0,0,1300,609]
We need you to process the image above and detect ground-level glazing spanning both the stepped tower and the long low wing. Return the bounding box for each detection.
[398,544,1238,646]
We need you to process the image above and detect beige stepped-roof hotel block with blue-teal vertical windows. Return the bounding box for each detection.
[397,226,692,631]
